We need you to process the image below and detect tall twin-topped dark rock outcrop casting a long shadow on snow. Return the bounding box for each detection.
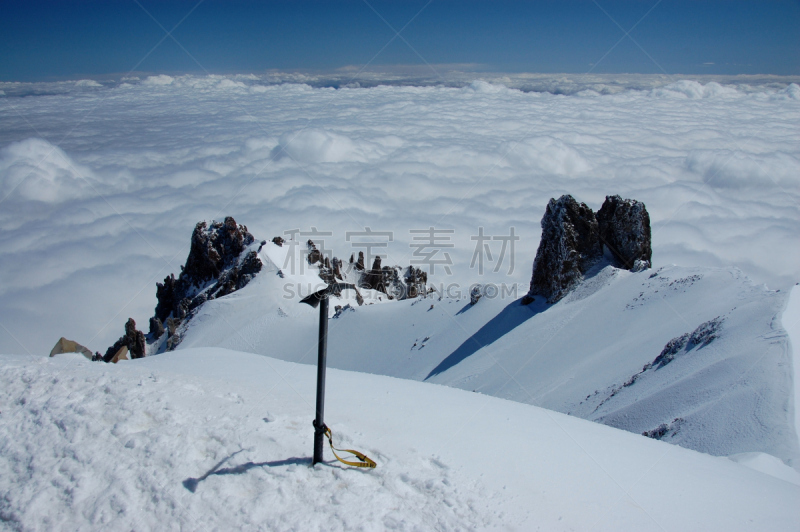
[522,195,652,304]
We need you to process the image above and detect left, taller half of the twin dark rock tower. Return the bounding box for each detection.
[528,195,602,303]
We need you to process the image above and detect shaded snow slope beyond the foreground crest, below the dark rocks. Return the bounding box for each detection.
[172,239,800,465]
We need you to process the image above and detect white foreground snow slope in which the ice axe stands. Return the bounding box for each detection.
[0,349,800,531]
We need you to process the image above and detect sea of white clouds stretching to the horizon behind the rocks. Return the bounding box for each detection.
[0,75,800,354]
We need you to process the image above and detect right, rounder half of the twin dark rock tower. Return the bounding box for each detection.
[597,196,653,271]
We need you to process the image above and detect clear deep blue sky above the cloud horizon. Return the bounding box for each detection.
[0,0,800,81]
